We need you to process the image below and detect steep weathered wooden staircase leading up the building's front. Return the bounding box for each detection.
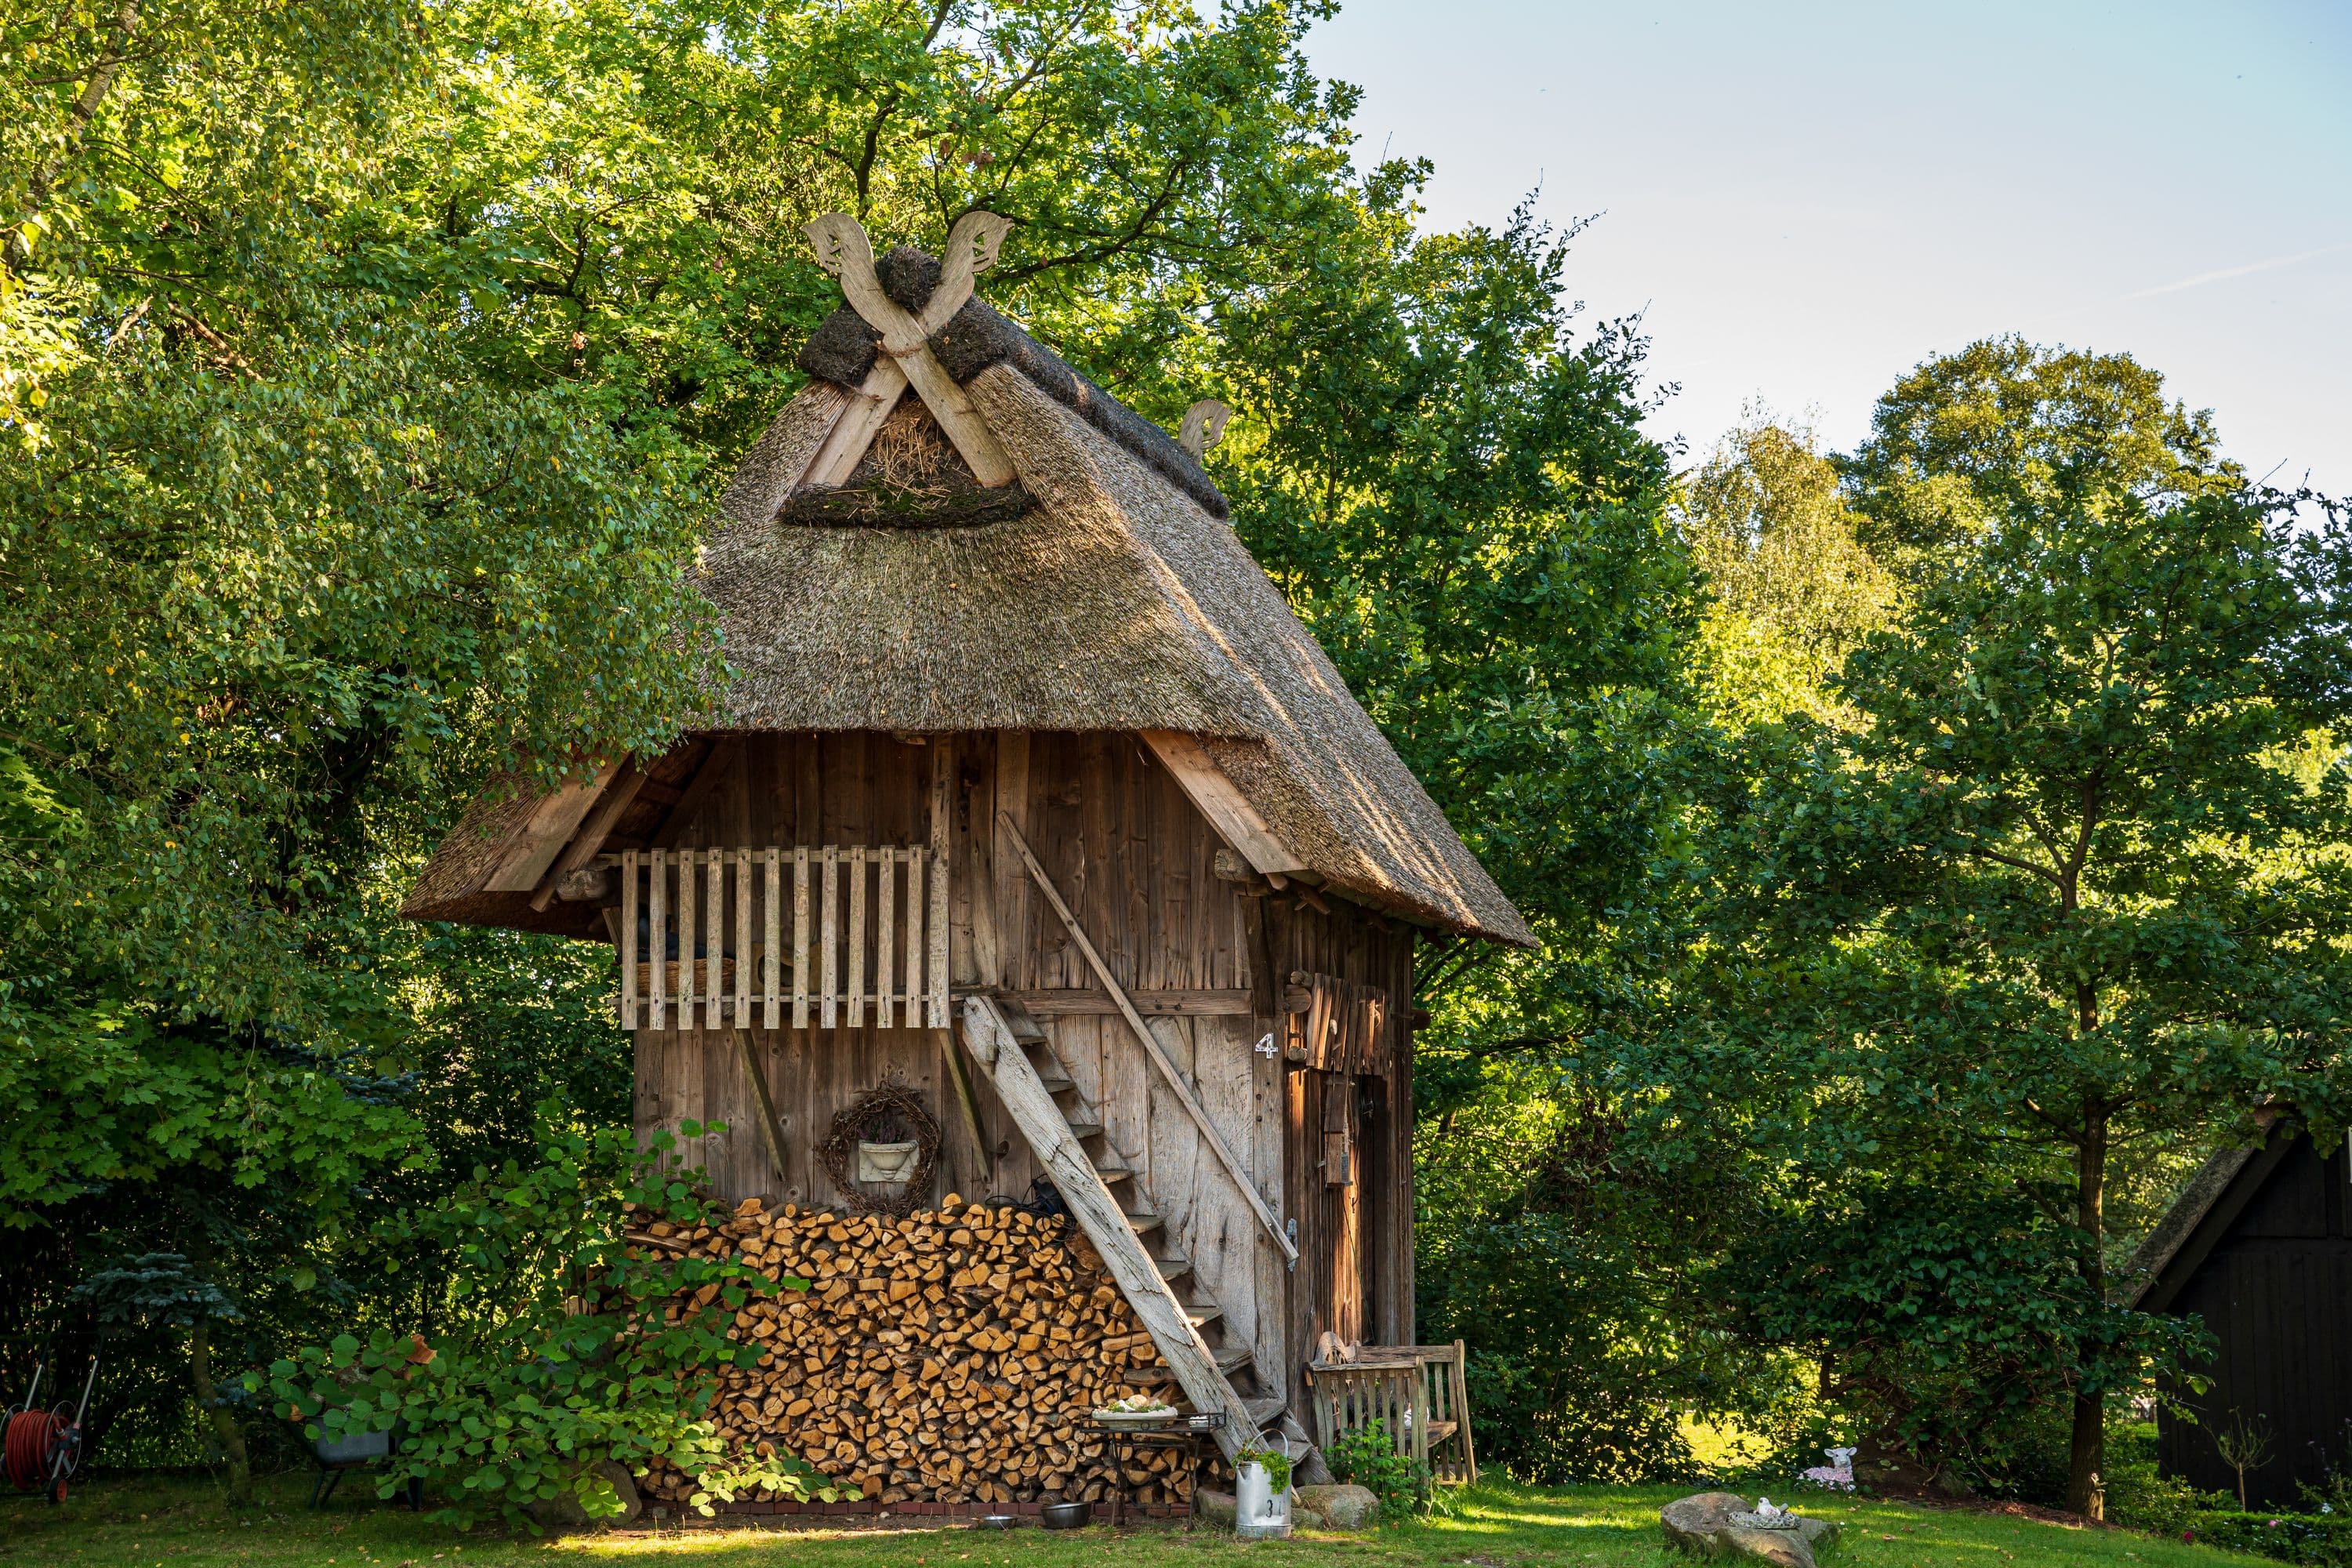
[960,994,1284,1460]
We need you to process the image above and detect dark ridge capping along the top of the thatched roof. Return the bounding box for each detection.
[800,245,1228,517]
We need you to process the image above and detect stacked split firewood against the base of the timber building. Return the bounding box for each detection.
[628,1194,1181,1504]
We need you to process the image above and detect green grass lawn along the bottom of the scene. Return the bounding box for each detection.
[0,1476,2263,1568]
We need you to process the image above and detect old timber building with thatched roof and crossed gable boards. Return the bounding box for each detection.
[405,214,1534,1507]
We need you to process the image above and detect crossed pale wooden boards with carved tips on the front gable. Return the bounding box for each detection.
[804,212,1016,489]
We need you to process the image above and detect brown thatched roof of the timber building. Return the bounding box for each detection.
[412,252,1534,942]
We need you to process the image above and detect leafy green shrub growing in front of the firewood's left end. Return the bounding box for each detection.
[266,1123,835,1523]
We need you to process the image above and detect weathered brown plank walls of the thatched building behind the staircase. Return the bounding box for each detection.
[637,734,1414,1408]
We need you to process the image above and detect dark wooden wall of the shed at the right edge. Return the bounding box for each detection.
[2157,1133,2352,1507]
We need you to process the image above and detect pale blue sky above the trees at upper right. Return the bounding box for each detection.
[1308,0,2352,496]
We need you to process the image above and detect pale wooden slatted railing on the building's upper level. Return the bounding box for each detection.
[612,844,948,1029]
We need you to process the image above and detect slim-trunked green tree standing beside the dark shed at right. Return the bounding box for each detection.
[1724,346,2352,1514]
